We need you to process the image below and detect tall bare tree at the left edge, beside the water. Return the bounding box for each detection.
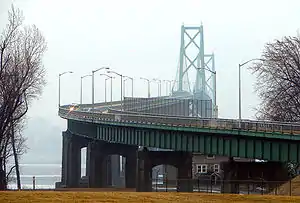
[0,6,46,190]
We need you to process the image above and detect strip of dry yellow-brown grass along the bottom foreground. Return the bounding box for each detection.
[0,191,300,203]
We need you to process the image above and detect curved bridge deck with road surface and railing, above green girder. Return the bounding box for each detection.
[59,101,300,140]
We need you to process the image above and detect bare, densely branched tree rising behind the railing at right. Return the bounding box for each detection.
[250,36,300,122]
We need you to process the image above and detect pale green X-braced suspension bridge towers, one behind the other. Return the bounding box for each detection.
[172,25,217,117]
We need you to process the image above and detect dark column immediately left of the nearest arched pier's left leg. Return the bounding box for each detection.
[125,150,137,188]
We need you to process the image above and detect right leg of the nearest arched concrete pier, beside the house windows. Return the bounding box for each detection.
[177,152,193,192]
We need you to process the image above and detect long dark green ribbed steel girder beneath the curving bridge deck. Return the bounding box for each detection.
[68,120,300,162]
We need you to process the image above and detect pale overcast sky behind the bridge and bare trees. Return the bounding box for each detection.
[0,0,300,127]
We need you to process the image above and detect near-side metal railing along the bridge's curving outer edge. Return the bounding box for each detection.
[59,107,300,135]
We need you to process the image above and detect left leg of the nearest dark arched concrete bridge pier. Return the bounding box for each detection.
[136,148,152,192]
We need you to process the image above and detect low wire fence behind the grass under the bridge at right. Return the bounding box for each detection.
[152,179,300,196]
